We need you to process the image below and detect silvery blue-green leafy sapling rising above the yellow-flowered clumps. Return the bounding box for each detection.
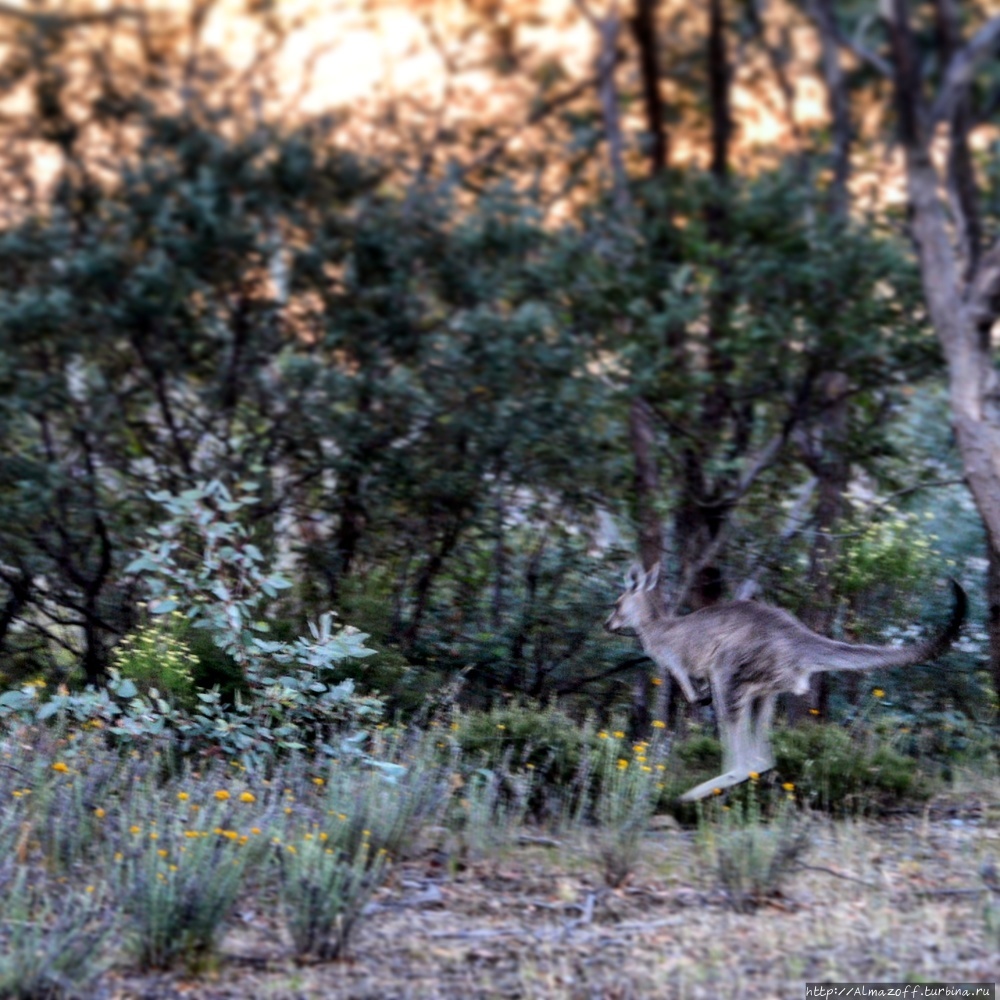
[106,480,383,766]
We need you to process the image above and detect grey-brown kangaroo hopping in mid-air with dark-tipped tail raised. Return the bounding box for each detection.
[604,566,968,802]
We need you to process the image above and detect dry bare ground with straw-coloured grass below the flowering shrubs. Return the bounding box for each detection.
[101,796,1000,1000]
